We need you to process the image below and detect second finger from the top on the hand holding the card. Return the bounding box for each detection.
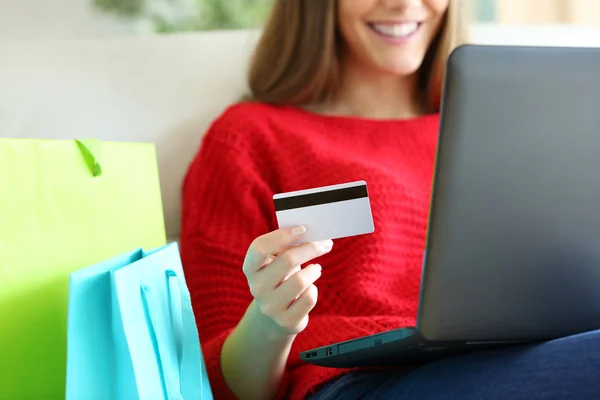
[247,240,333,297]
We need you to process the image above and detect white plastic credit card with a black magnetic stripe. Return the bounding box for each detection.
[273,181,375,243]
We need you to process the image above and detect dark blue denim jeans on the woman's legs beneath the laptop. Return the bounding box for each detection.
[310,331,600,400]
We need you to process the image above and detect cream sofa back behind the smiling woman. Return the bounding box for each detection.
[0,25,600,240]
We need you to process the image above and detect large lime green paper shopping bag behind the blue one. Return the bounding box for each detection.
[0,139,166,400]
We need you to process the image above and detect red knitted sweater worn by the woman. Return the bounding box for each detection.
[181,103,439,400]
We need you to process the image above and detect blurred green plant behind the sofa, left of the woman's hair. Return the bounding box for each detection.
[91,0,273,33]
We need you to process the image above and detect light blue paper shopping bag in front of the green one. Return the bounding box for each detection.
[66,243,213,400]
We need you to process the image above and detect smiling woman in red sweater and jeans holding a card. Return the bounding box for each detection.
[181,0,600,400]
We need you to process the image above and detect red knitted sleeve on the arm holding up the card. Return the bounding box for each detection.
[180,120,275,399]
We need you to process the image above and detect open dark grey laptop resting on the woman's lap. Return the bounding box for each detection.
[300,45,600,368]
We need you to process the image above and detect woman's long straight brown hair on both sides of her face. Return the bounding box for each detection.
[247,0,468,111]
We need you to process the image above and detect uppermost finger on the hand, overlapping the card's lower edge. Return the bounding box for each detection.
[244,226,306,274]
